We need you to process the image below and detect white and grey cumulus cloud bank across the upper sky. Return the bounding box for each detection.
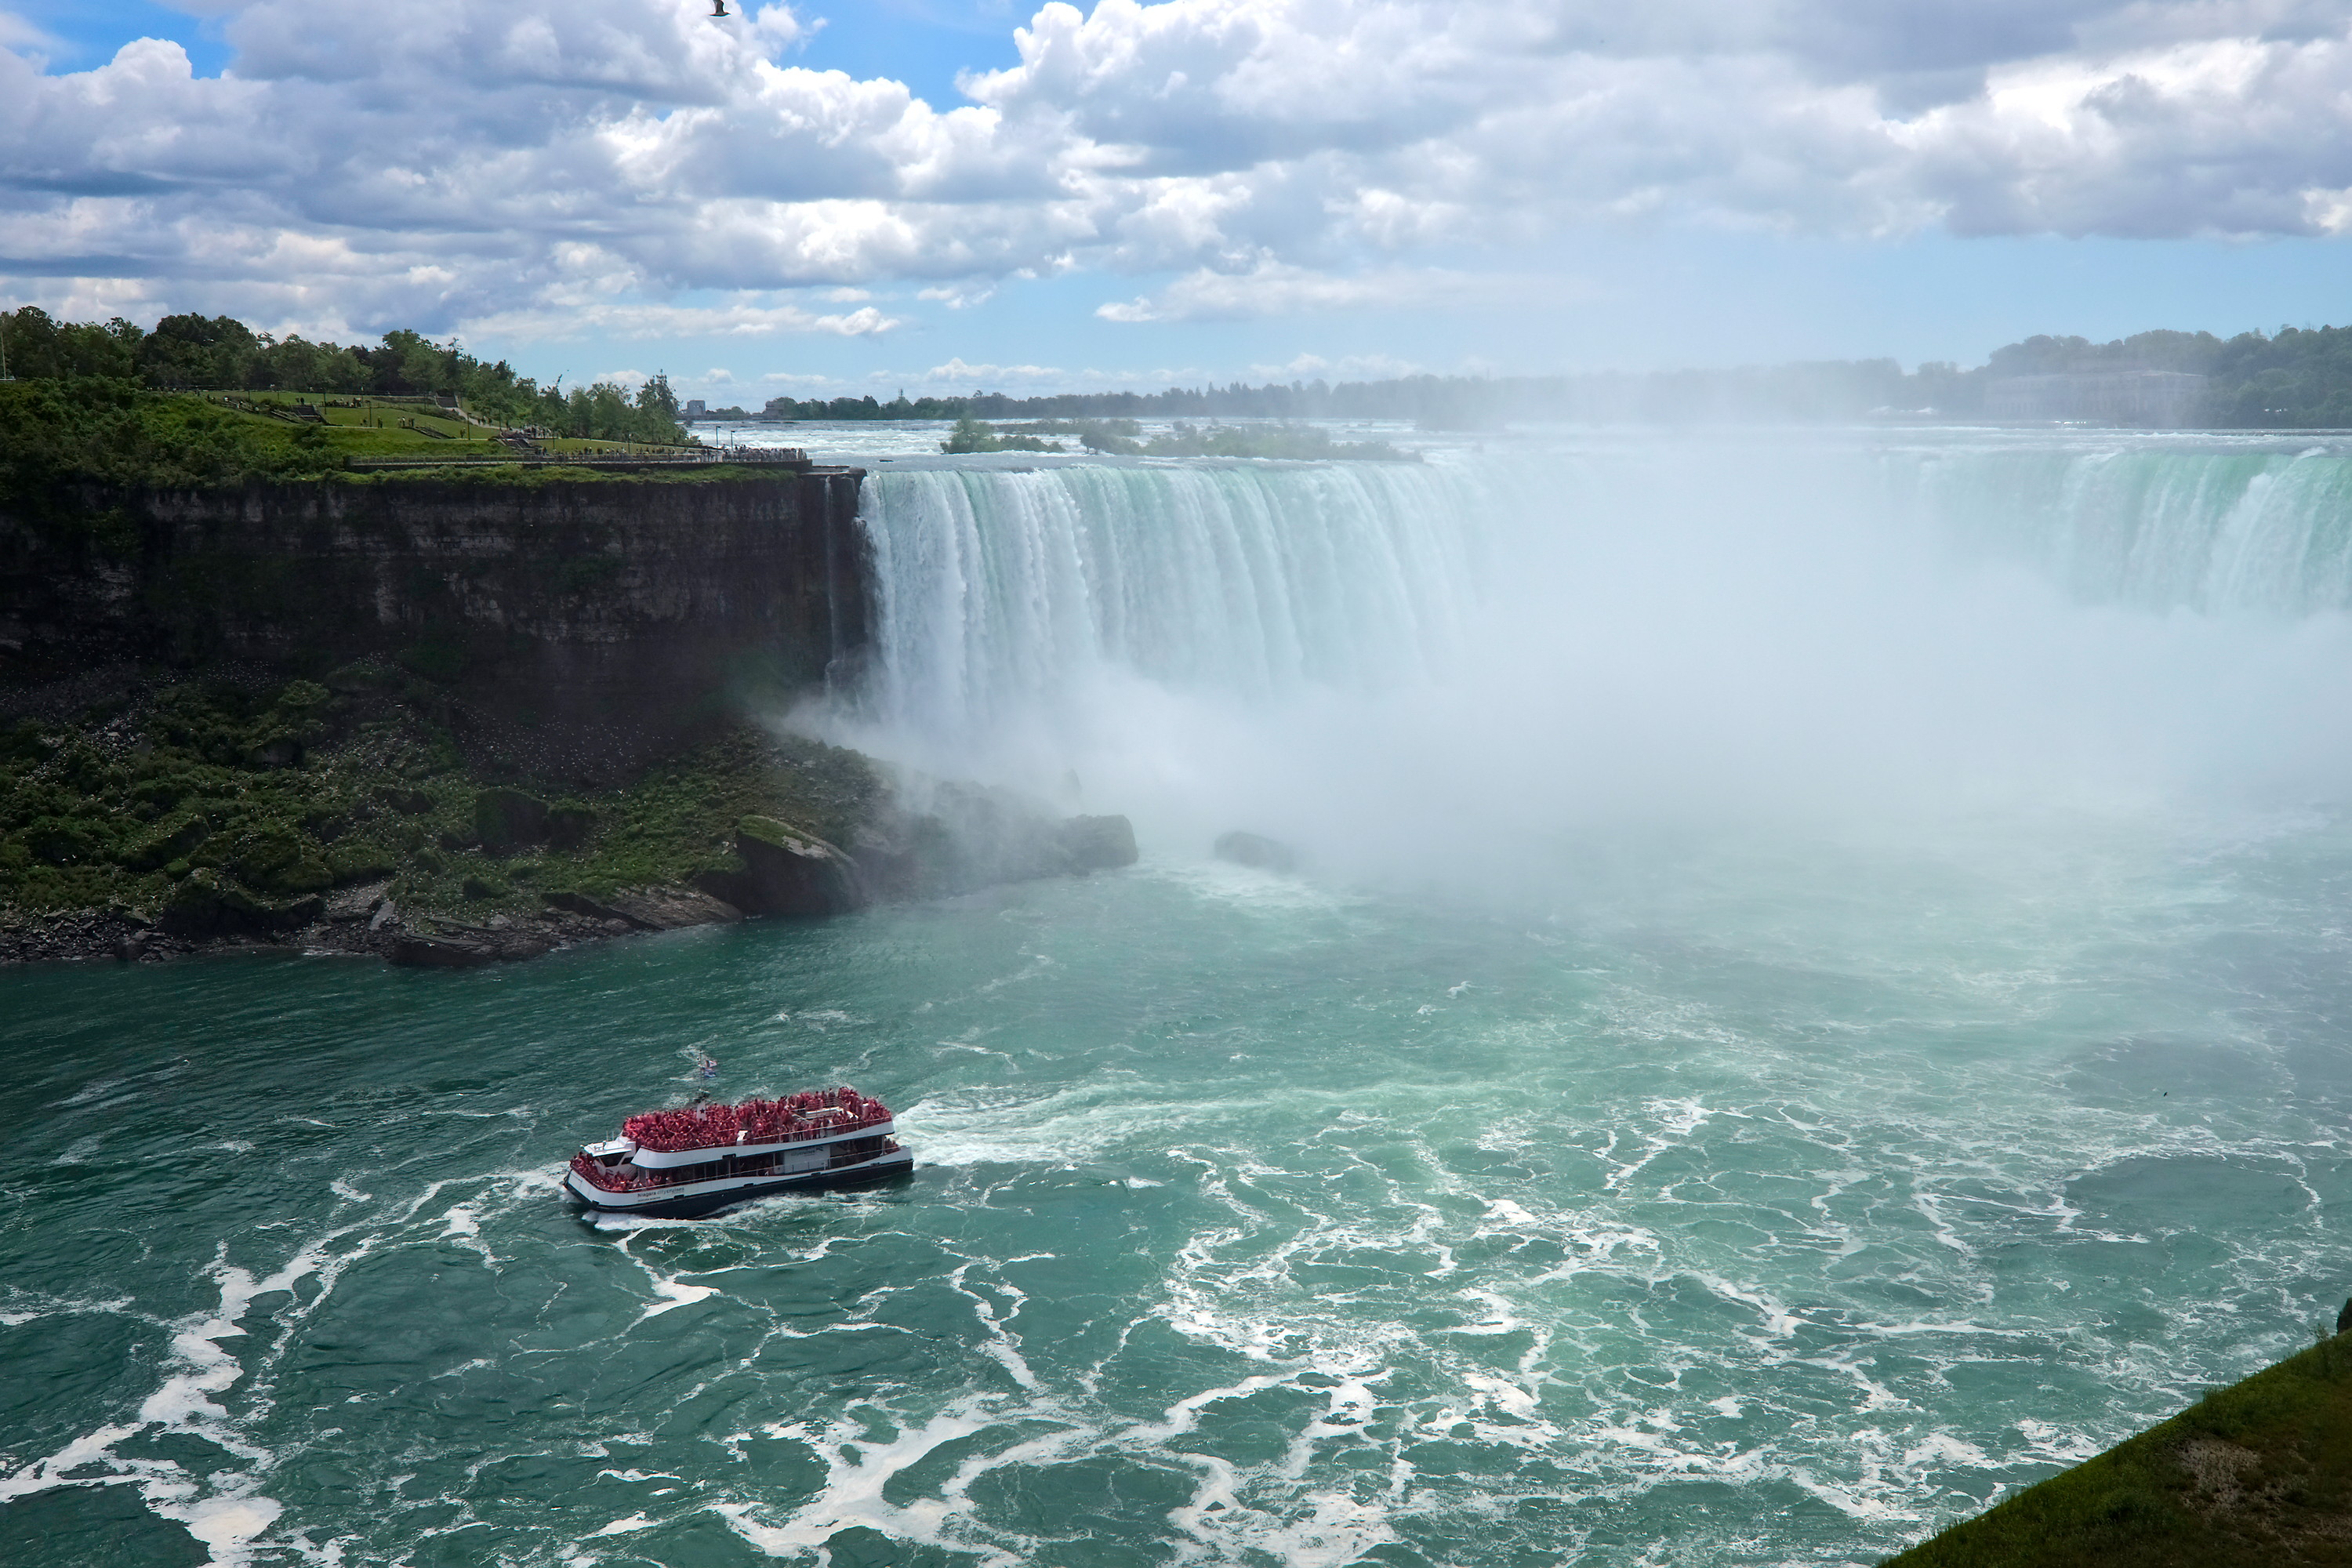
[0,0,2352,336]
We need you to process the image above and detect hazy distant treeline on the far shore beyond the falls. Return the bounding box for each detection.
[748,327,2352,430]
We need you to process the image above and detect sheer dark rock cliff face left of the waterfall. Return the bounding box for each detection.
[0,468,868,742]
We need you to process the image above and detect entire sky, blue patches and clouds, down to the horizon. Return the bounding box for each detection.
[0,0,2352,402]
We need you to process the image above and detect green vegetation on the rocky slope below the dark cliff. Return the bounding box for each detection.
[0,666,882,931]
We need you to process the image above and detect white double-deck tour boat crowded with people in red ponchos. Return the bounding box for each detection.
[564,1086,915,1220]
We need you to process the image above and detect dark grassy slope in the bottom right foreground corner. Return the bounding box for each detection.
[1886,1335,2352,1568]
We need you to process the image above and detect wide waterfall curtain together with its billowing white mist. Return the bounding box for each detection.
[842,435,2352,862]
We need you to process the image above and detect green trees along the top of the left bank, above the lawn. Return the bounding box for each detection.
[0,306,684,442]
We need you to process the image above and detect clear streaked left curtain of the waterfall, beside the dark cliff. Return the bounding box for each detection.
[863,463,1494,736]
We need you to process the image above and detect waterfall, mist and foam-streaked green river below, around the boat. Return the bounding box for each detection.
[0,430,2352,1568]
